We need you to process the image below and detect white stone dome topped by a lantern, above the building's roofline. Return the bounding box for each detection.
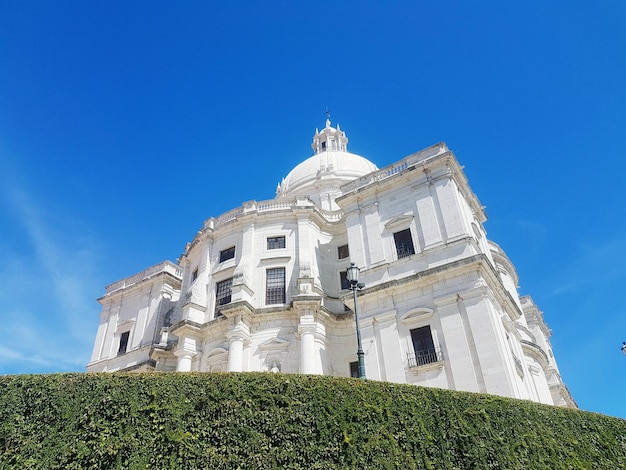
[276,120,378,210]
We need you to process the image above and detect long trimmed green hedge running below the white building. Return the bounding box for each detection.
[0,373,626,470]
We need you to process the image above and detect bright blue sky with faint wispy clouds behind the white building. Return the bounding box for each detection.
[0,0,626,418]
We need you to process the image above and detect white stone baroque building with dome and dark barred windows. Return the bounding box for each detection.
[87,121,576,407]
